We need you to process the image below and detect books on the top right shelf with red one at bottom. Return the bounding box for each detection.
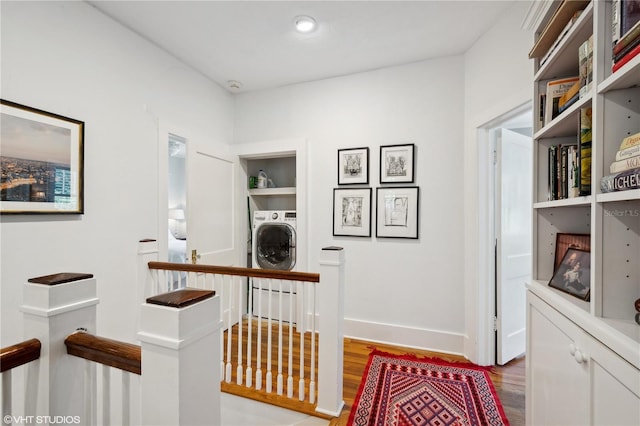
[611,0,640,72]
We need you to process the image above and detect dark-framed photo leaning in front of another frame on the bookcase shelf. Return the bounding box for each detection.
[549,247,591,301]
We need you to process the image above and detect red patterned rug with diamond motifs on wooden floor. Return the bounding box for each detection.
[348,350,509,426]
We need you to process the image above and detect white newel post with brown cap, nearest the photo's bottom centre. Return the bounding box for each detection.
[138,288,222,426]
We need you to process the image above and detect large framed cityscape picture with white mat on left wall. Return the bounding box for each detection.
[0,99,84,214]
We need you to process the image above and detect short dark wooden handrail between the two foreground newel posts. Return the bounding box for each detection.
[64,331,142,374]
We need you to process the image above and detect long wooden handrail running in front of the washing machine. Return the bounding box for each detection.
[148,262,320,283]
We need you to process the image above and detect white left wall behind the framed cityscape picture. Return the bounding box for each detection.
[0,2,233,346]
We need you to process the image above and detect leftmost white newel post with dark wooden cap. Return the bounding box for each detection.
[20,273,98,424]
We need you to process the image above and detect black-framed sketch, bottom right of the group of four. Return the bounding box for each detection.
[376,186,420,239]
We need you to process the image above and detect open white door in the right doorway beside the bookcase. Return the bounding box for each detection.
[495,129,533,365]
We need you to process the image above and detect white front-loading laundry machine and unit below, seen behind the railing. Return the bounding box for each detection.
[251,210,297,322]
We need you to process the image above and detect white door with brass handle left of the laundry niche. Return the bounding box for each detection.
[187,141,241,266]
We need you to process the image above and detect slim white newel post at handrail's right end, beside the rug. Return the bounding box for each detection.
[316,247,344,417]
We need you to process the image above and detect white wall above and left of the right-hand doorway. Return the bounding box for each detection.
[462,1,533,364]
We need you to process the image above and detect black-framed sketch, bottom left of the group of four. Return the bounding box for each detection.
[333,188,371,237]
